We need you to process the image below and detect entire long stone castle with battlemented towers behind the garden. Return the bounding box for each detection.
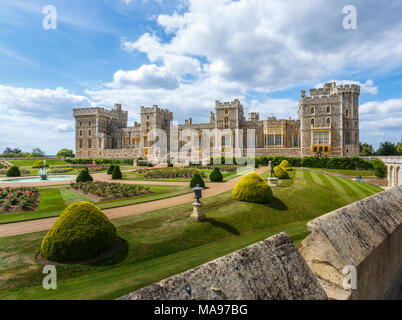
[73,83,360,159]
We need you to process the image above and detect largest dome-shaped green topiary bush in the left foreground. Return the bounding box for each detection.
[40,201,117,262]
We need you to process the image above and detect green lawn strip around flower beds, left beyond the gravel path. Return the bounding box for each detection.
[0,186,192,224]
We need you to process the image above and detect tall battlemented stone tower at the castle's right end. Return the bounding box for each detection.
[298,83,360,157]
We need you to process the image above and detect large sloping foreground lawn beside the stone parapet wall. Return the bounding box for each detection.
[0,170,382,299]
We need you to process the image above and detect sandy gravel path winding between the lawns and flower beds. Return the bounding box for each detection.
[0,167,267,238]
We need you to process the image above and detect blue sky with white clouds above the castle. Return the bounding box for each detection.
[0,0,402,154]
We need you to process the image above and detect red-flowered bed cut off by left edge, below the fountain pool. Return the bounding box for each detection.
[0,187,40,213]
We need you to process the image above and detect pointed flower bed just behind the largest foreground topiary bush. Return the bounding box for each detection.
[70,182,151,202]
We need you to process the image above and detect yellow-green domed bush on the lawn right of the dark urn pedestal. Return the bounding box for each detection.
[232,172,273,203]
